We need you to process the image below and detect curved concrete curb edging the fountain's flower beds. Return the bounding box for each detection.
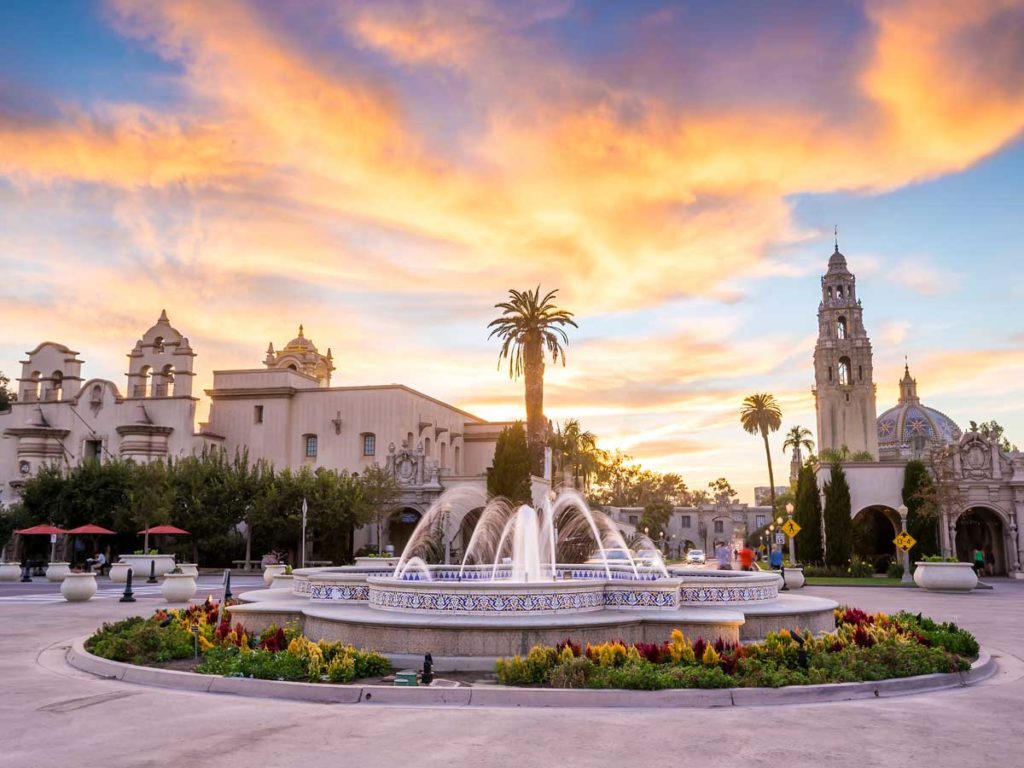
[67,637,997,709]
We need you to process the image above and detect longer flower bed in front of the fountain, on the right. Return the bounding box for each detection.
[497,608,979,690]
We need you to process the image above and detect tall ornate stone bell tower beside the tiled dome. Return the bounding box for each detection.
[814,238,879,461]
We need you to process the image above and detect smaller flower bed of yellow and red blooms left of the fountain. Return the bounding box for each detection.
[85,600,391,683]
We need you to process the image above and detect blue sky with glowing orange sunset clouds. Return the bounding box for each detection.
[0,0,1024,501]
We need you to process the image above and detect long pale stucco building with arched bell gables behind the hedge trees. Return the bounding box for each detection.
[0,312,528,561]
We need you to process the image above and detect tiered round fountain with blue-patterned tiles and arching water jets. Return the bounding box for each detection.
[232,488,836,660]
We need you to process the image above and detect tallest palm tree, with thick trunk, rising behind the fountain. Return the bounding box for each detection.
[487,286,578,474]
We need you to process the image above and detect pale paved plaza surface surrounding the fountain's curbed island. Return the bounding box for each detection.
[0,582,1024,768]
